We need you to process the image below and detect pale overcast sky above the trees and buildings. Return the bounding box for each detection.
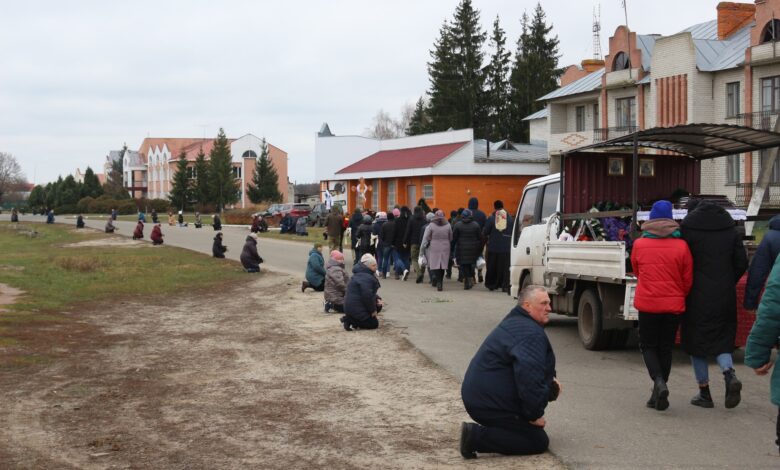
[0,0,718,183]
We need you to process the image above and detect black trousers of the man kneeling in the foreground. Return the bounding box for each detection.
[467,410,550,455]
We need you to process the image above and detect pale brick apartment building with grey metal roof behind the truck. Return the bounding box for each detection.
[526,0,780,205]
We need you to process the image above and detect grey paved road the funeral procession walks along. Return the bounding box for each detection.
[7,215,780,469]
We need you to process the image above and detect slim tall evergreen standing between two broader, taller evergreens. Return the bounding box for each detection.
[485,15,512,142]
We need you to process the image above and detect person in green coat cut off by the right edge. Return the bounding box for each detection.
[745,253,780,456]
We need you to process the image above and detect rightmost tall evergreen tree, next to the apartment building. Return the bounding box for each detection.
[510,3,563,142]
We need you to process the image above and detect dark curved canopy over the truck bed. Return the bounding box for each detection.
[565,124,780,160]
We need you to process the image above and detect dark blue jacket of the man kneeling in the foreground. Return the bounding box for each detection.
[460,307,555,421]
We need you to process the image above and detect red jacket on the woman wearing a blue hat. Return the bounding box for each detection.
[631,237,693,314]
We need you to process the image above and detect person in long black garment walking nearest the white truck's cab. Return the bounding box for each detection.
[482,201,513,293]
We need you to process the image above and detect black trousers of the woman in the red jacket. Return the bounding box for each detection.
[639,312,680,382]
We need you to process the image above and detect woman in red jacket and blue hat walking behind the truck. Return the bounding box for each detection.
[631,201,693,410]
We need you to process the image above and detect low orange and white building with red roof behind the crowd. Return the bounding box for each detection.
[315,125,549,211]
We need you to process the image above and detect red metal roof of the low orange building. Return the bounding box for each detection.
[336,142,468,174]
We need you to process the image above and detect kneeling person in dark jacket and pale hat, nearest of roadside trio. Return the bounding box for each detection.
[341,255,382,331]
